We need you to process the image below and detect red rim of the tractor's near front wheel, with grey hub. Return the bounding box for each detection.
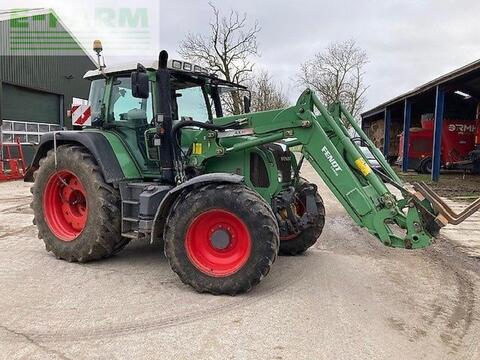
[185,209,252,277]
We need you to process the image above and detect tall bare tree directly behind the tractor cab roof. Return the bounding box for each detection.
[178,3,260,114]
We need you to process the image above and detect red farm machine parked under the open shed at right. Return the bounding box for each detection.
[397,118,480,173]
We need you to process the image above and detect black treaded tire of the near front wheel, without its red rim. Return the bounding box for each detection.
[164,184,279,295]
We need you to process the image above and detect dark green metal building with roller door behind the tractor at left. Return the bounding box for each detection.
[0,9,95,162]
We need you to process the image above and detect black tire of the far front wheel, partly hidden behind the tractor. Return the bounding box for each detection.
[279,178,325,256]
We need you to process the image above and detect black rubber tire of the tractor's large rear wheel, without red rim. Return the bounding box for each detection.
[31,145,129,262]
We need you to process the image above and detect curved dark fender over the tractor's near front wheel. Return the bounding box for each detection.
[151,173,244,242]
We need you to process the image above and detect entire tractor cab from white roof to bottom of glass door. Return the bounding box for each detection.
[84,55,249,175]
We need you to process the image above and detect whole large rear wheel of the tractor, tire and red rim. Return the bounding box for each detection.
[31,145,128,262]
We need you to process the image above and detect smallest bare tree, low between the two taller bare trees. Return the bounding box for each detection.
[248,70,288,111]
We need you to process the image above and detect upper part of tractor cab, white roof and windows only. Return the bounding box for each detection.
[84,60,248,126]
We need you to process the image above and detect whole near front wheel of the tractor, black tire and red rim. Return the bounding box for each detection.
[164,184,279,295]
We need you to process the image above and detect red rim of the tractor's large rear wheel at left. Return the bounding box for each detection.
[43,170,88,241]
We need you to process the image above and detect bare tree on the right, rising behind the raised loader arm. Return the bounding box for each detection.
[297,40,368,125]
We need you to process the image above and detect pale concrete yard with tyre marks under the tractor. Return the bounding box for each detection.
[0,166,480,359]
